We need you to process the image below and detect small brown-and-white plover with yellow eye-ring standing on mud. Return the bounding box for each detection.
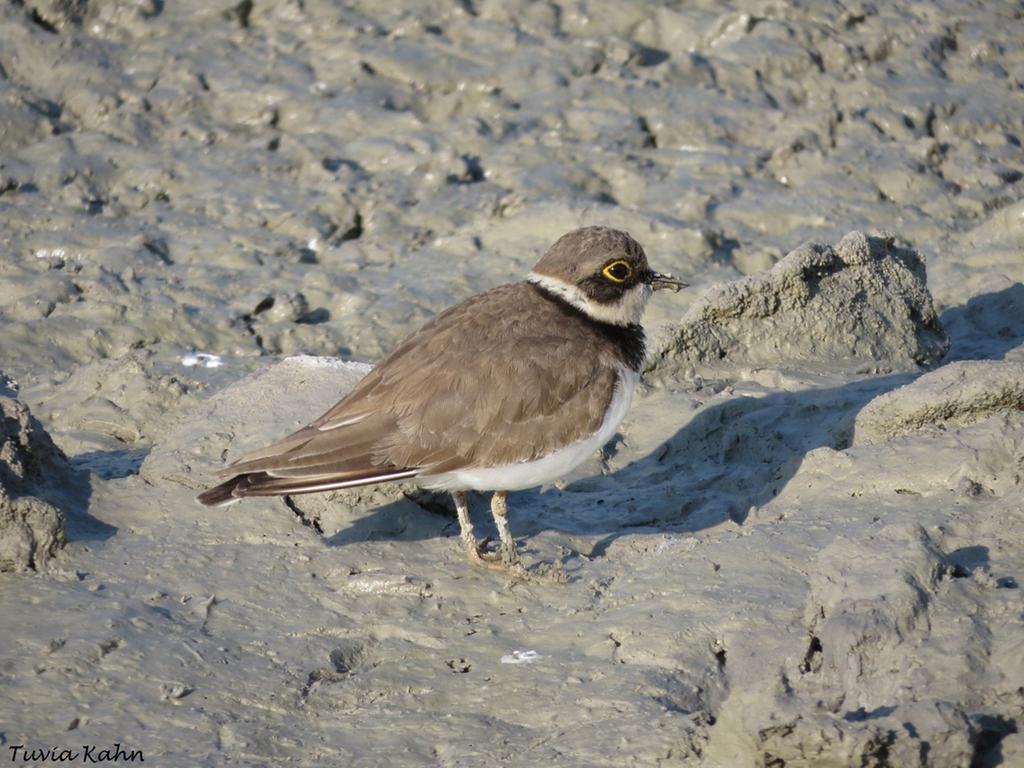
[198,226,687,571]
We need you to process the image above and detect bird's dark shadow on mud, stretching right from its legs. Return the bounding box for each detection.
[513,374,918,558]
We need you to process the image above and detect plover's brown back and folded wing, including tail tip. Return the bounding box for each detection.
[199,283,622,505]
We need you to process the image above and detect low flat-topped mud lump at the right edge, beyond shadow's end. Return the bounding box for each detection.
[853,360,1024,444]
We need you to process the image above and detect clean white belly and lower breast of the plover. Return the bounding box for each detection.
[416,369,639,490]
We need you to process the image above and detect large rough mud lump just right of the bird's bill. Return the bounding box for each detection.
[650,231,949,375]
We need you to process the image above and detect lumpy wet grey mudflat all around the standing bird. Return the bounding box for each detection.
[0,0,1024,768]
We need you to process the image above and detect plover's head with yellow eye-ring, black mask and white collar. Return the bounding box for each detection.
[528,226,686,326]
